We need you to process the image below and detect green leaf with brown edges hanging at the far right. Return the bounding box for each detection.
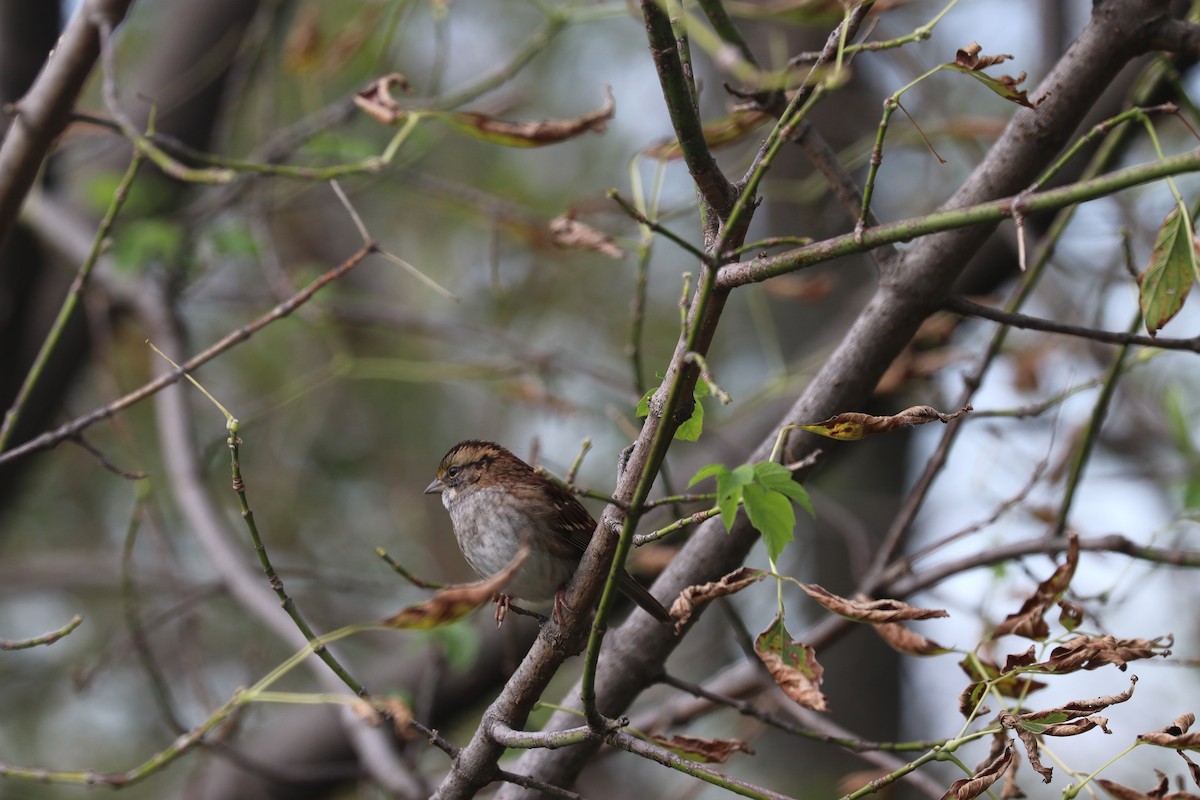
[1138,204,1196,336]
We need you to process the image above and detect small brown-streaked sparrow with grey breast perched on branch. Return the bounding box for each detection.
[425,439,671,622]
